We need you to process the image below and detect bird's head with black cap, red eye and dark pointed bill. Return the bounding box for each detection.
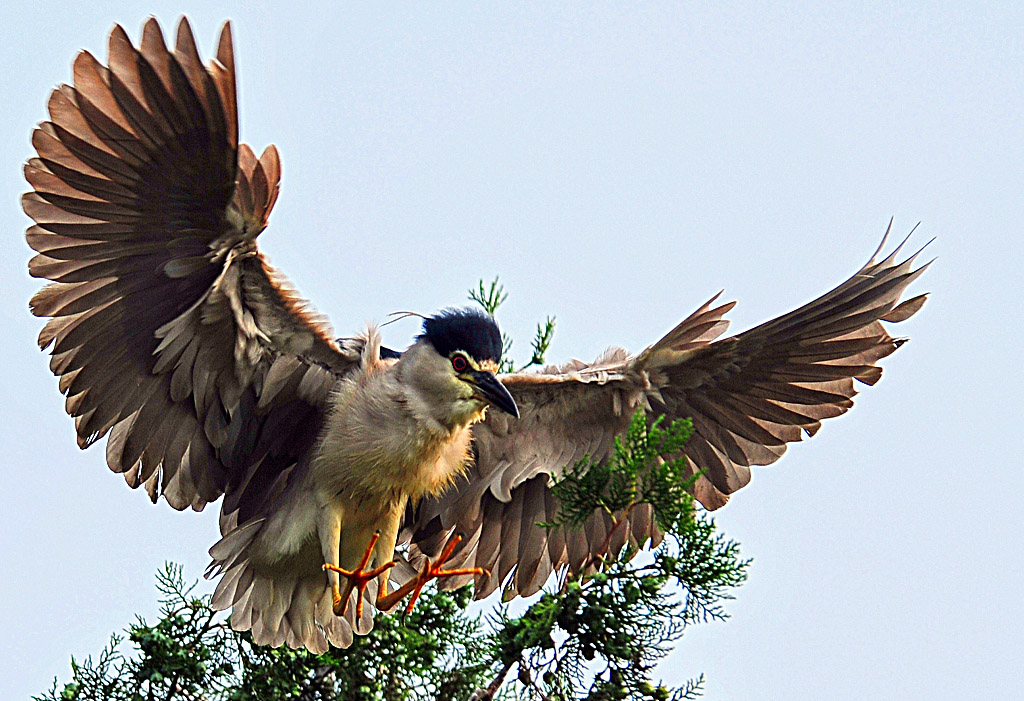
[402,309,519,424]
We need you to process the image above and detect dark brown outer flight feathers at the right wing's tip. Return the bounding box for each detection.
[636,231,928,499]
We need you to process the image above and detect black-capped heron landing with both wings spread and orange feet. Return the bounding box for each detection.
[23,18,930,653]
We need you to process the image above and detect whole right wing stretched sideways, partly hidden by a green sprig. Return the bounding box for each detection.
[407,227,928,598]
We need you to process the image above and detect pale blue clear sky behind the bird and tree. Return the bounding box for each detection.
[0,0,1024,700]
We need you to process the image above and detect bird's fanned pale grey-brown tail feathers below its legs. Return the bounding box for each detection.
[206,519,377,654]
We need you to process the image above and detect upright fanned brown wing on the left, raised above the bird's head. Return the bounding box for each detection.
[23,19,353,522]
